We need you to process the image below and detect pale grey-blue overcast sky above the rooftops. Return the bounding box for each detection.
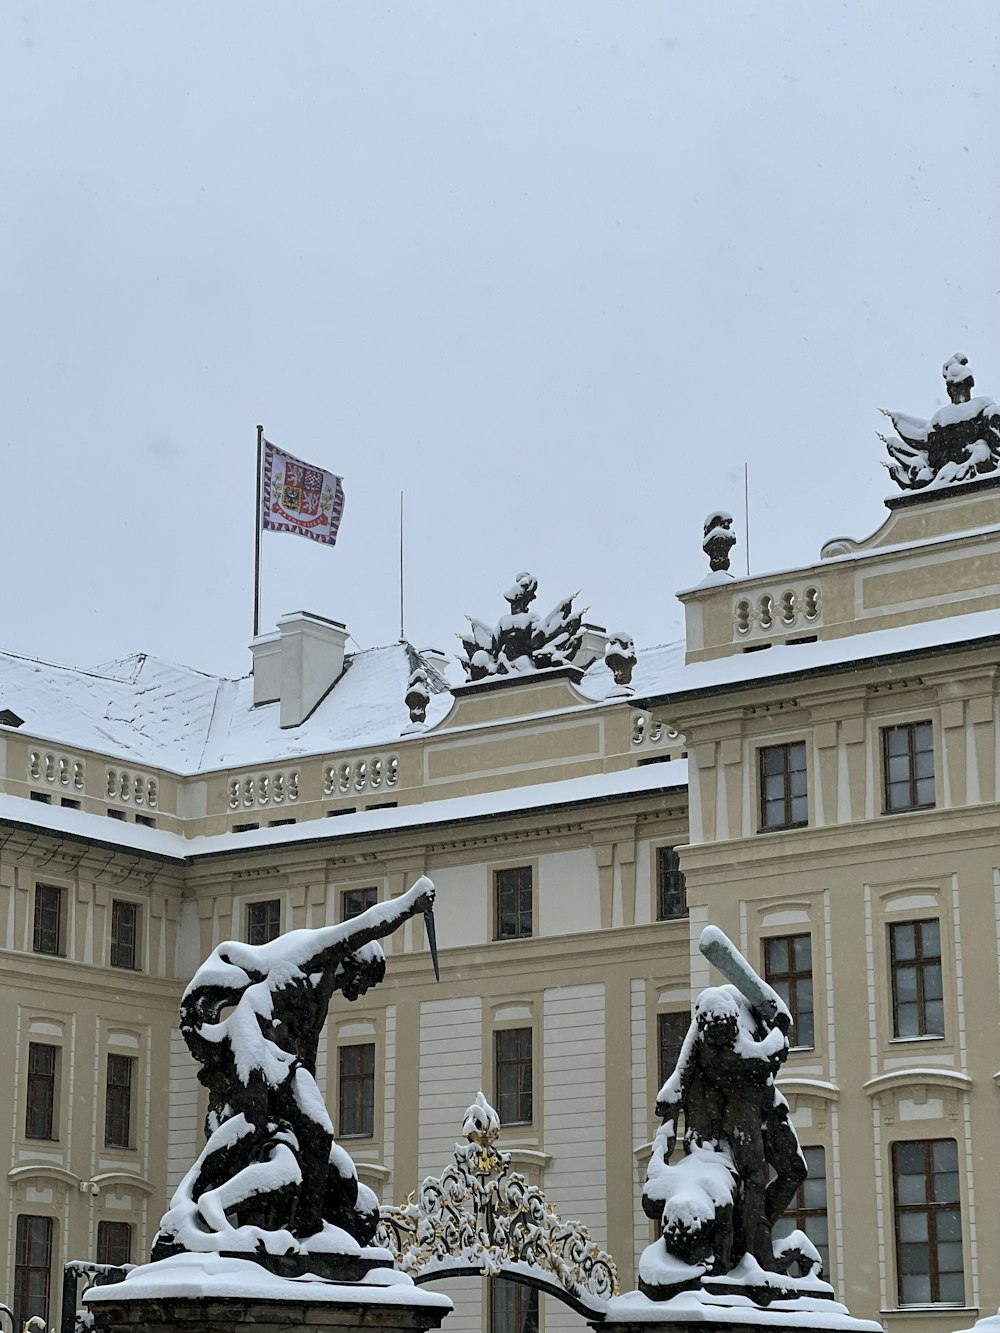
[0,0,1000,674]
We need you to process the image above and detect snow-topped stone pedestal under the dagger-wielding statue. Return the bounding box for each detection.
[84,1254,452,1333]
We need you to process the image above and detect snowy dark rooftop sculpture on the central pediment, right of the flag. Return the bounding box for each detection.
[459,573,587,680]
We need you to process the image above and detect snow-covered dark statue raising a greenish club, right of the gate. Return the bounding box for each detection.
[639,926,832,1300]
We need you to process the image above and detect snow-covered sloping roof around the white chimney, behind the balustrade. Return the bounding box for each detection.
[0,643,451,774]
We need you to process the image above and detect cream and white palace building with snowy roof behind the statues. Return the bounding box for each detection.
[0,471,1000,1333]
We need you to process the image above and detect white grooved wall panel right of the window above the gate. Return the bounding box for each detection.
[543,982,608,1333]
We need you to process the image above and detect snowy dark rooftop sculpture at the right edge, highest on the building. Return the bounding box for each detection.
[879,352,1000,491]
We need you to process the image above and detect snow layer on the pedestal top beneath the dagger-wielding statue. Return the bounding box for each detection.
[83,1254,453,1312]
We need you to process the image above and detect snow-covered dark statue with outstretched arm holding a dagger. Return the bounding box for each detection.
[152,877,437,1276]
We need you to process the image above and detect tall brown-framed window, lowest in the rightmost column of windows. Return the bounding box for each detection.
[892,1138,965,1305]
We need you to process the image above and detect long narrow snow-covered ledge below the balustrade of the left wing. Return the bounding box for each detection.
[0,760,688,861]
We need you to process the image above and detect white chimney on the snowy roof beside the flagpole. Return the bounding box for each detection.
[251,611,348,726]
